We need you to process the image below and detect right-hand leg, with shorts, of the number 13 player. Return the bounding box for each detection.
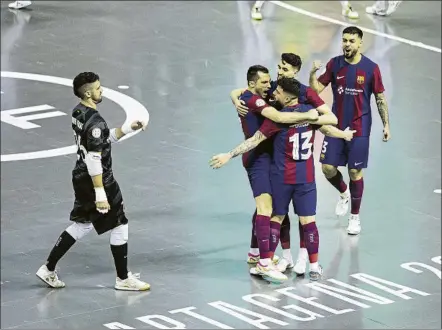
[293,182,322,281]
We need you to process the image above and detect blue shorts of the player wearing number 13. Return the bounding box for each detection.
[271,176,317,217]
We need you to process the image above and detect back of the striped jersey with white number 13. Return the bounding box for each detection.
[272,104,317,184]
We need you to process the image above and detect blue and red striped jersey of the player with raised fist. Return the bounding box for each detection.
[318,55,385,136]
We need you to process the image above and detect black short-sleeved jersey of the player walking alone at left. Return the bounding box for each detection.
[72,103,113,184]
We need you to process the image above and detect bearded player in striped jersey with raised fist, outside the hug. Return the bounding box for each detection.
[310,26,390,235]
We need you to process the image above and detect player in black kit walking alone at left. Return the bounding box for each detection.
[36,72,150,291]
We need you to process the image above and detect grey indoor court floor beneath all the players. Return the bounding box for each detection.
[1,1,441,329]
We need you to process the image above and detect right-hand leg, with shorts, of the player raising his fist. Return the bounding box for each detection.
[347,136,370,235]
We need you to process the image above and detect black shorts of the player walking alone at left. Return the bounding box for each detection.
[70,176,128,235]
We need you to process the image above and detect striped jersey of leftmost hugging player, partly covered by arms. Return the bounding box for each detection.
[239,90,272,167]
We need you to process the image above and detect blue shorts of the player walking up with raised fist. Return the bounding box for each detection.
[319,136,370,170]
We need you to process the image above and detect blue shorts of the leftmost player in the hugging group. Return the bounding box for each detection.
[246,154,272,197]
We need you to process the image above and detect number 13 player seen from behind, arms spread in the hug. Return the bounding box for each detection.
[210,78,355,280]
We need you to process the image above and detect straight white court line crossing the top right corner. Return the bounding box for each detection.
[270,1,442,53]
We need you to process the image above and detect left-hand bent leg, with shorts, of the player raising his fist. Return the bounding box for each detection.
[320,136,350,216]
